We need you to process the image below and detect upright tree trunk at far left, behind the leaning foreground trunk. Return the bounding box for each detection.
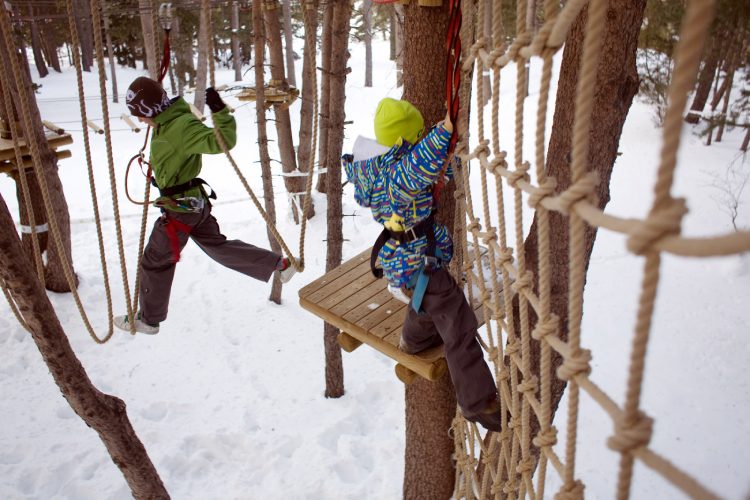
[0,28,77,292]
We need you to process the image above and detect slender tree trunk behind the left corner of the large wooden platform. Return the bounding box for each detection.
[323,0,352,398]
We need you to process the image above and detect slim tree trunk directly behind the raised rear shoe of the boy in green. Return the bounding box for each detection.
[253,1,281,304]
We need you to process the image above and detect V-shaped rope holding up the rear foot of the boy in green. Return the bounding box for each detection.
[201,0,318,272]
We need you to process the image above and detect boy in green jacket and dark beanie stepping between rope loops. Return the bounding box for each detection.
[115,77,295,335]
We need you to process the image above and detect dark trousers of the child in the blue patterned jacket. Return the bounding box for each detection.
[401,269,497,414]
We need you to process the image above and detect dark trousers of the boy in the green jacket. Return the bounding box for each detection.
[140,203,281,324]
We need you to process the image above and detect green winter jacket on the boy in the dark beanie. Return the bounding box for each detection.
[150,97,237,211]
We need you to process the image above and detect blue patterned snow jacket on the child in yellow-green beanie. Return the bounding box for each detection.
[341,125,453,287]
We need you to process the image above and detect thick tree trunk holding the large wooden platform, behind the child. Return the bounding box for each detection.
[400,2,456,499]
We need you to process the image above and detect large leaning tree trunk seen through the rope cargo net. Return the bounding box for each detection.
[515,0,646,446]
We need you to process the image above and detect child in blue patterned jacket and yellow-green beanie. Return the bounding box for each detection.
[342,98,501,431]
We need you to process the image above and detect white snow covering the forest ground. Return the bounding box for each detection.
[0,36,750,499]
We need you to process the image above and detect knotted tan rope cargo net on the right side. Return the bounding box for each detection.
[452,0,750,500]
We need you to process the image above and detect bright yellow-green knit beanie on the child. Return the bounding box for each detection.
[375,97,424,147]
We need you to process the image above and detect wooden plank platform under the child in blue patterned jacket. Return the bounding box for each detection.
[299,248,482,383]
